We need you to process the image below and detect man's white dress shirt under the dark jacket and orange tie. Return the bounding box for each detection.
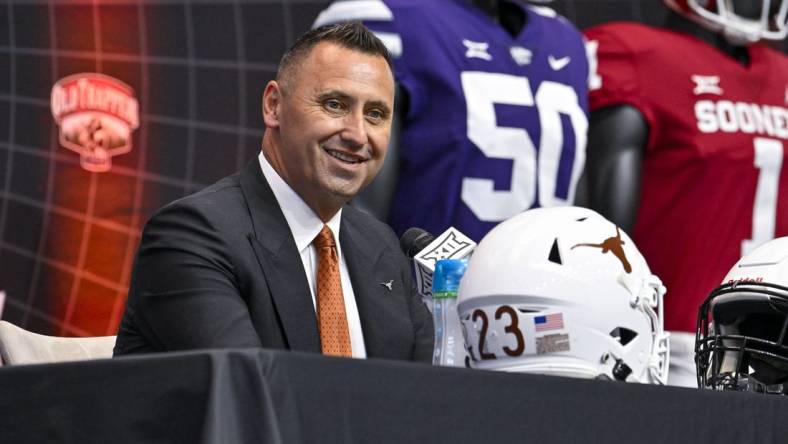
[258,151,367,358]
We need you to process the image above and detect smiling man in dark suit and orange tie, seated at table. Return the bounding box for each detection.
[115,23,433,362]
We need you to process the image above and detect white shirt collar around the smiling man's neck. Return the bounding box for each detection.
[258,150,342,253]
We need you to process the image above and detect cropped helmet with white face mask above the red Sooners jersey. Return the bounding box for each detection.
[664,0,788,45]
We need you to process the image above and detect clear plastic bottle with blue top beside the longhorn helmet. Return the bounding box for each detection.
[432,259,468,367]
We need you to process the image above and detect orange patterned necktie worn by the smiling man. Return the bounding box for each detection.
[313,225,352,356]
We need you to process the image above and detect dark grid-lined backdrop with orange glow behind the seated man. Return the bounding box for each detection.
[0,0,784,336]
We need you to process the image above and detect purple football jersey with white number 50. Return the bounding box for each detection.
[316,0,588,241]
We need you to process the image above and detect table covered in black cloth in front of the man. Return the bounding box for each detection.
[0,349,788,444]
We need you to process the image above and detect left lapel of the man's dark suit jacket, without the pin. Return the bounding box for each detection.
[240,157,320,352]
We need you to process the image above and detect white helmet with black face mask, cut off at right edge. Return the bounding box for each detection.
[695,237,788,395]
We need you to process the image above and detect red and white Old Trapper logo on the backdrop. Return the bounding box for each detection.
[50,73,139,172]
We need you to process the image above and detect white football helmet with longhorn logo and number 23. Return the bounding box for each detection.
[458,207,669,384]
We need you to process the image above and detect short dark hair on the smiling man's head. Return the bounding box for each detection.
[276,22,394,92]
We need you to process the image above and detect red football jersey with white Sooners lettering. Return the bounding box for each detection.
[586,23,788,331]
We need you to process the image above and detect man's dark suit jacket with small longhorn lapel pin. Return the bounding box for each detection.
[115,158,433,362]
